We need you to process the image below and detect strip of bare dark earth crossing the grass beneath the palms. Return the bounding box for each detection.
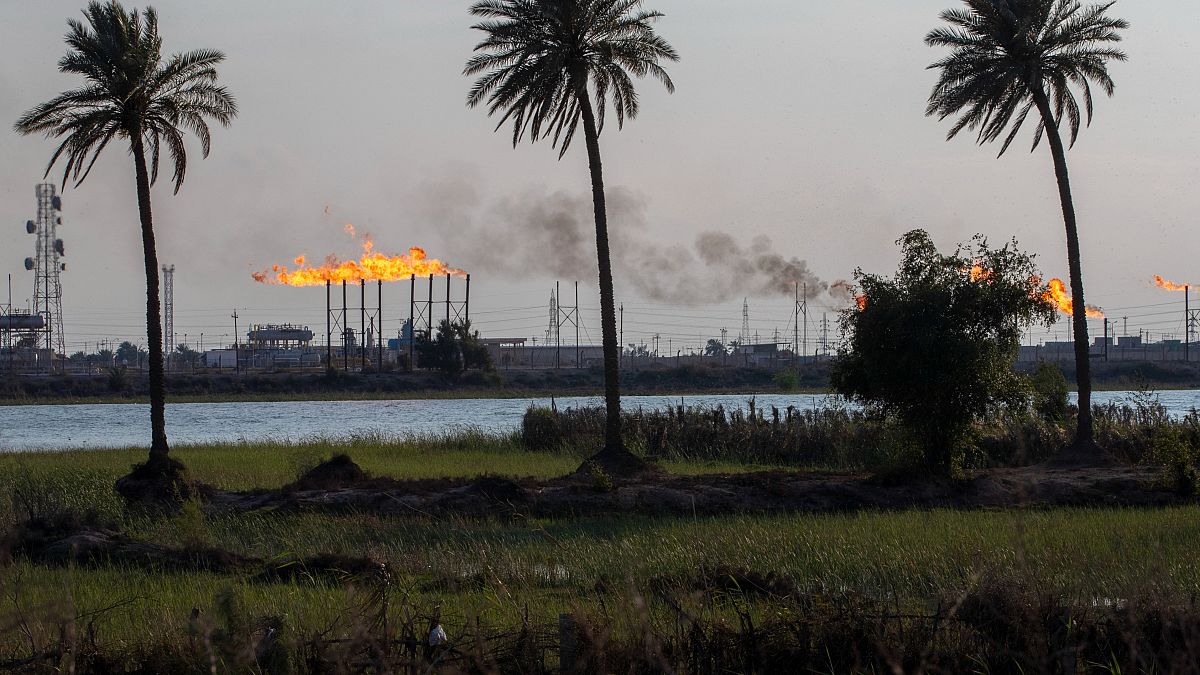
[206,458,1194,518]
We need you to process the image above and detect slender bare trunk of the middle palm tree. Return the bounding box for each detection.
[578,84,625,455]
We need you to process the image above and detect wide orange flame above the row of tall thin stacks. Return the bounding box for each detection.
[251,236,467,286]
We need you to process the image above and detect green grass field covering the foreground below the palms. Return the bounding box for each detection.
[0,436,1200,671]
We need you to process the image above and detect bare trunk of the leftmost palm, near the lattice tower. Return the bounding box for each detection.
[130,133,169,458]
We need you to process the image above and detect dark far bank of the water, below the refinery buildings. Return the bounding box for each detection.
[7,362,1200,406]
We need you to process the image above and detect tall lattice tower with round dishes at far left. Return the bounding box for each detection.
[25,183,67,365]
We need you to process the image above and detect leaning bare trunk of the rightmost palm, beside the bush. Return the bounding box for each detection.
[1032,80,1094,449]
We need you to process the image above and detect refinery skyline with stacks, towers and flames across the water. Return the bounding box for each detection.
[0,184,1200,375]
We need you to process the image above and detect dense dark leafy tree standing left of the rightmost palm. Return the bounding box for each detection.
[830,229,1054,474]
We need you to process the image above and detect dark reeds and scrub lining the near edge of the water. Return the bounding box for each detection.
[520,395,1200,471]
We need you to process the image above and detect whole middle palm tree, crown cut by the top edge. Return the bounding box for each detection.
[463,0,679,471]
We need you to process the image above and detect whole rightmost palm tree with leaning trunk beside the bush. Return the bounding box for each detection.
[925,0,1129,454]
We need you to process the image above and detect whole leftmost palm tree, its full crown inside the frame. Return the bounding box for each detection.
[16,0,238,478]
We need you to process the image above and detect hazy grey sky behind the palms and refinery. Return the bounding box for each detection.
[0,0,1200,351]
